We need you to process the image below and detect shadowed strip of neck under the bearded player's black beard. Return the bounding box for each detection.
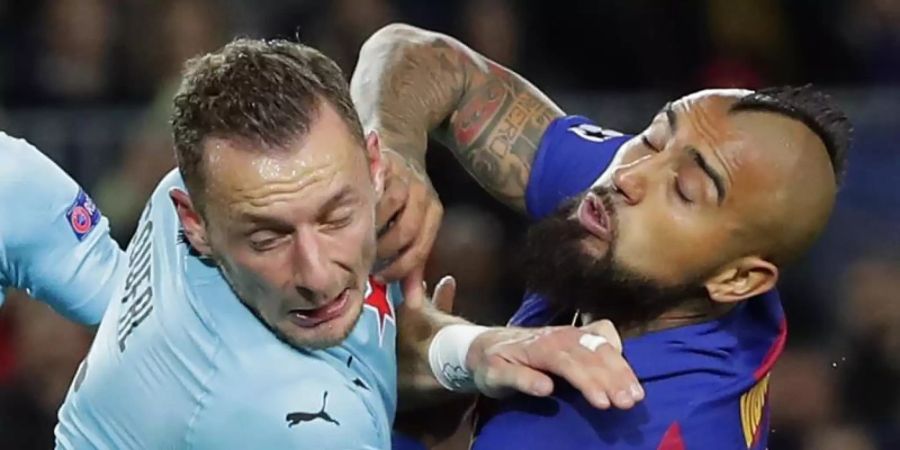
[573,298,734,339]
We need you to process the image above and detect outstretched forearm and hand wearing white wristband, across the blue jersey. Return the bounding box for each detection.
[397,279,643,414]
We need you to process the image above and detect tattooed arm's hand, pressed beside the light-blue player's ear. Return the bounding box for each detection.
[375,149,444,282]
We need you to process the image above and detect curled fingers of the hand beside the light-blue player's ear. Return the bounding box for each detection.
[378,192,444,281]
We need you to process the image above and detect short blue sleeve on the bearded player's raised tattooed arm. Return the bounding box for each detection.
[525,116,630,219]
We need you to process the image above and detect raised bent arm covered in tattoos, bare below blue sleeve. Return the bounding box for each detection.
[351,24,563,210]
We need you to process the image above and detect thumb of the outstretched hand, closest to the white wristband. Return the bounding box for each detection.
[475,357,553,398]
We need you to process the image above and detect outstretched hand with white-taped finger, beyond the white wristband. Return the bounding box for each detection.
[466,320,644,409]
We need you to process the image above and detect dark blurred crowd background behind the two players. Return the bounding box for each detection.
[0,0,900,450]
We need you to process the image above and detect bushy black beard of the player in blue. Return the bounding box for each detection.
[521,188,706,329]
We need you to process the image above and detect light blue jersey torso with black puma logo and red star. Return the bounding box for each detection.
[56,172,400,450]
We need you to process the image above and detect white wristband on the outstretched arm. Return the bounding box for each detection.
[428,324,489,392]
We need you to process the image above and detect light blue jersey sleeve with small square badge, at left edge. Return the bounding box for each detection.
[0,132,127,325]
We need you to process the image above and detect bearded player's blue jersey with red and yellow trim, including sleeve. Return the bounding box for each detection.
[473,117,786,450]
